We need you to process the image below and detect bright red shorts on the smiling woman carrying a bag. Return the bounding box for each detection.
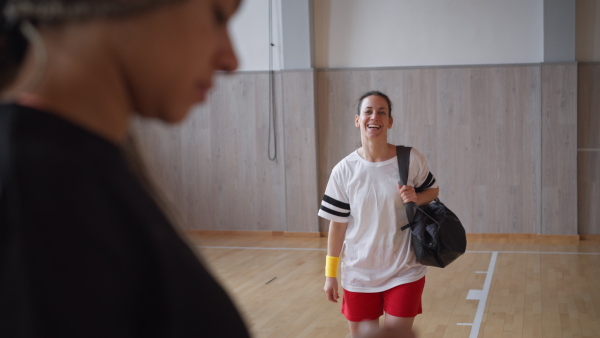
[342,277,425,322]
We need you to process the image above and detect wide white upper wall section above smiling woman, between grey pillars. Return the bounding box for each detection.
[314,0,543,68]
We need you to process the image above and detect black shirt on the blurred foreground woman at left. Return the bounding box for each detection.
[0,105,248,337]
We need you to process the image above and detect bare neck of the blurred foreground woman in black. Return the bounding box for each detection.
[12,23,133,144]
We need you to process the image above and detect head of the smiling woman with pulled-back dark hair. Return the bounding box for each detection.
[354,95,394,140]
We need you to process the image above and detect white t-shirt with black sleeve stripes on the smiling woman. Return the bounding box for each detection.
[318,148,438,292]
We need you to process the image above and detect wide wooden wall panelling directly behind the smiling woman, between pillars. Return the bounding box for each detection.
[317,66,541,233]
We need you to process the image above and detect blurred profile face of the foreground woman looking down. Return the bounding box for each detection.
[115,0,239,122]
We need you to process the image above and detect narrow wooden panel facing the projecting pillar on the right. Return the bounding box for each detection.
[540,64,577,235]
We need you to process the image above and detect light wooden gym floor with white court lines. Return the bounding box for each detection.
[192,234,600,338]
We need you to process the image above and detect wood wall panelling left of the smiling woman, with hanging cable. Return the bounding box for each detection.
[134,71,319,232]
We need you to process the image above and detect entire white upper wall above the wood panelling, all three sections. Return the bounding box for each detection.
[230,0,600,71]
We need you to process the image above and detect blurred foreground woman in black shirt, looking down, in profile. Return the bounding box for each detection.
[0,0,248,337]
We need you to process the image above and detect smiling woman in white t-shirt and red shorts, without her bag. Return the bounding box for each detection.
[319,91,439,337]
